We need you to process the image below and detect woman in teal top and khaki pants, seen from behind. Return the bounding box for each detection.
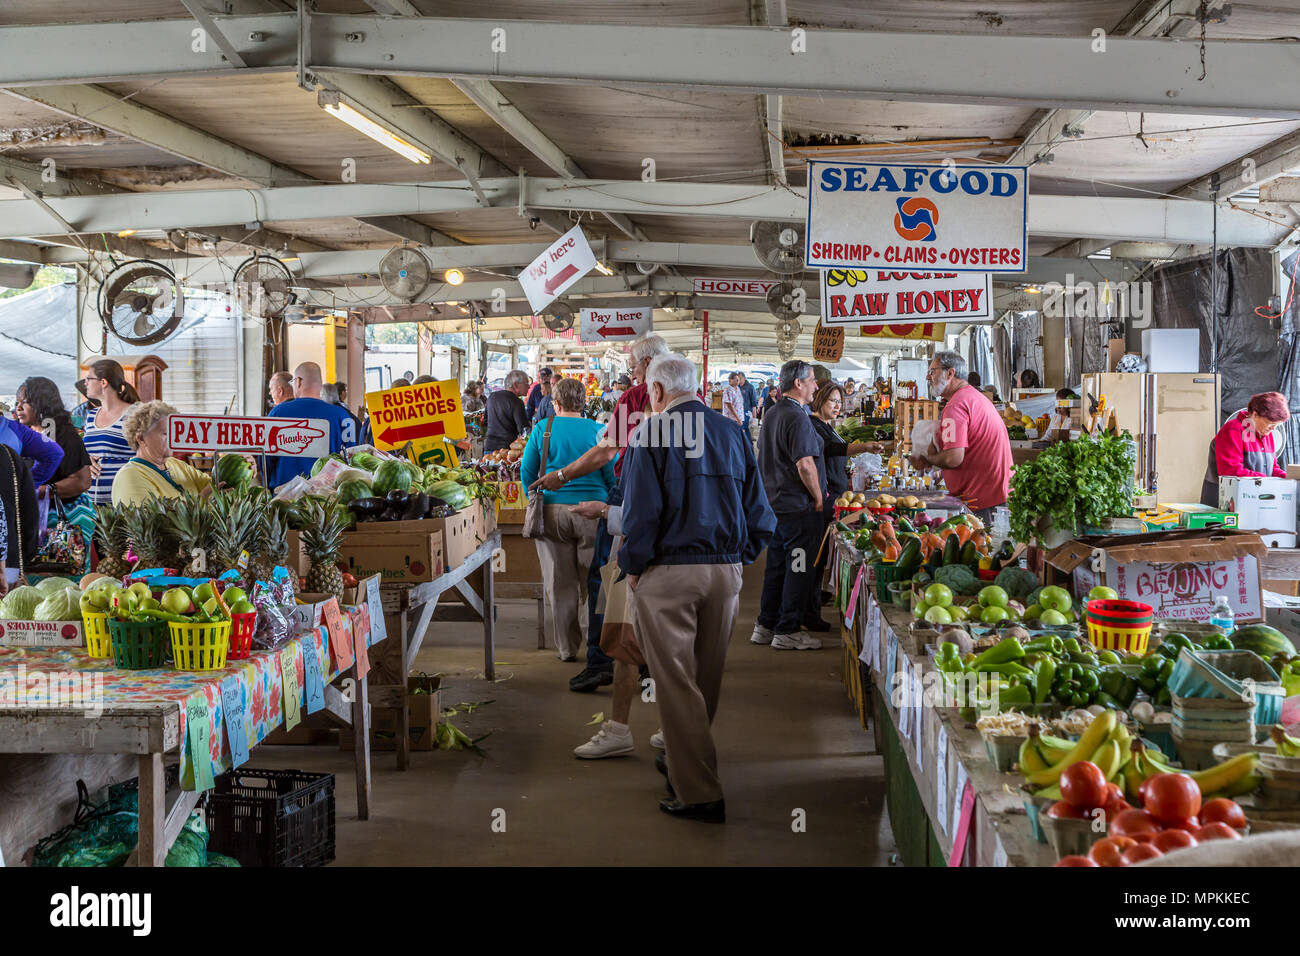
[519,378,614,661]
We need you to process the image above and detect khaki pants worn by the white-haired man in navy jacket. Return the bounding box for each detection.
[633,564,741,804]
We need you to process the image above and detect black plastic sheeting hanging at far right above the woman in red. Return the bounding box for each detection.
[1152,248,1279,424]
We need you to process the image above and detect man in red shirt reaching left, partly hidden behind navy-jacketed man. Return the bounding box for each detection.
[528,336,668,702]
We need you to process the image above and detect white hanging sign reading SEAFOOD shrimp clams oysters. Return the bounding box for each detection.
[805,163,1028,272]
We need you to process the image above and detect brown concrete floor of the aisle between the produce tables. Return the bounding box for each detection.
[251,562,893,866]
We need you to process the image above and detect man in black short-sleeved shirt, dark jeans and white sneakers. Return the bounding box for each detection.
[750,362,826,650]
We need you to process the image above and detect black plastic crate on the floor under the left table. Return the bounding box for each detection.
[207,767,334,866]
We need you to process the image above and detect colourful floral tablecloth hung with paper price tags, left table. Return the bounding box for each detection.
[0,606,369,790]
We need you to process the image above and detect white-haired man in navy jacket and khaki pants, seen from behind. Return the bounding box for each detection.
[619,355,776,823]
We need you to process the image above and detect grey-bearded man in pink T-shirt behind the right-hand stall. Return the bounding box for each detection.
[911,351,1011,524]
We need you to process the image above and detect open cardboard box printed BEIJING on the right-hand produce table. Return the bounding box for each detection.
[1047,529,1265,622]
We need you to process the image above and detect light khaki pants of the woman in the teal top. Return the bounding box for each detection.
[537,505,595,661]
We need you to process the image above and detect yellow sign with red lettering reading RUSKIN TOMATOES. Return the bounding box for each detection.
[365,380,465,464]
